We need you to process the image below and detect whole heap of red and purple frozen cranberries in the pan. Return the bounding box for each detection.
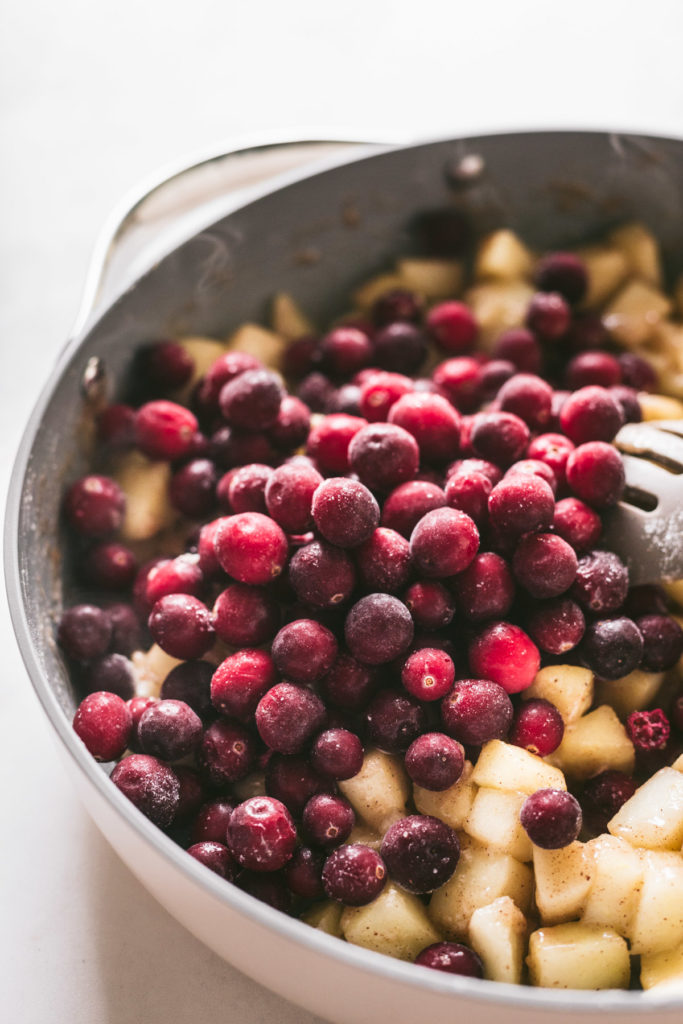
[57,243,683,974]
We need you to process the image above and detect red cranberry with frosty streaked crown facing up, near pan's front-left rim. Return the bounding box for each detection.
[227,797,296,871]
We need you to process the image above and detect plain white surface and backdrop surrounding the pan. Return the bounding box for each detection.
[0,0,683,1024]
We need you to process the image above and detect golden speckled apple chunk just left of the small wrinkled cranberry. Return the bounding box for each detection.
[549,705,635,778]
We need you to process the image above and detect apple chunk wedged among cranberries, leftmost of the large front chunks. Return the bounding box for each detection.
[339,750,411,836]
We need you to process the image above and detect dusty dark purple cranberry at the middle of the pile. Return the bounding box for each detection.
[344,594,414,665]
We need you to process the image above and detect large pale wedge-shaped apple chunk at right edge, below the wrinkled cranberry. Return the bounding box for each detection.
[607,768,683,850]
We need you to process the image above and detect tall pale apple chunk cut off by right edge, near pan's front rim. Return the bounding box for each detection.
[629,850,683,954]
